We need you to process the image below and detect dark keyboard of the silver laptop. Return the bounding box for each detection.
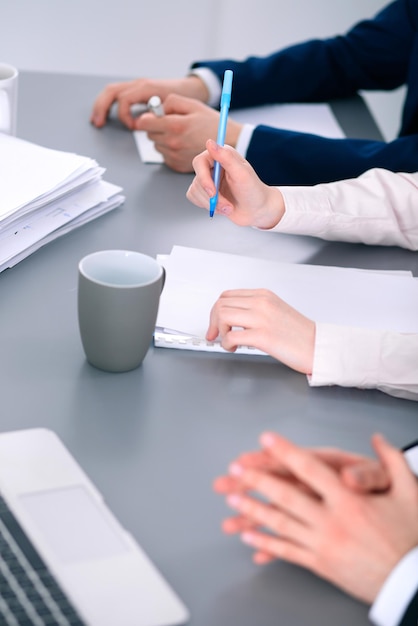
[0,496,86,626]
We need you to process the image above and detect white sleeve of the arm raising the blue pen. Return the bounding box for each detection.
[269,168,418,250]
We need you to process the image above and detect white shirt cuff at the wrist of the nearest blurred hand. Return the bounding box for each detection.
[369,546,418,626]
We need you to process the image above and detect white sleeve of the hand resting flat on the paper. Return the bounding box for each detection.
[308,323,418,401]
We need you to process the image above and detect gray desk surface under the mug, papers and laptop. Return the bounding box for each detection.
[0,73,418,626]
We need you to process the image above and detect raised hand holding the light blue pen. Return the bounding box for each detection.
[186,140,285,228]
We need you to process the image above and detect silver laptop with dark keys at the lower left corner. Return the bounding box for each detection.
[0,428,189,626]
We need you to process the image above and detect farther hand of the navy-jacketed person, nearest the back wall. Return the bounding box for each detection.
[90,75,209,130]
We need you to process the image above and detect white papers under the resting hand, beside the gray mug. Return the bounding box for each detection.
[154,246,418,352]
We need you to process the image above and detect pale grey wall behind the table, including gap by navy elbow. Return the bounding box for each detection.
[0,0,404,139]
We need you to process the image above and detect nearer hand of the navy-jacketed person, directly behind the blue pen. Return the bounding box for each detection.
[135,93,241,173]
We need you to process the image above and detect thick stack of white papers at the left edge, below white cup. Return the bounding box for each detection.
[0,133,125,271]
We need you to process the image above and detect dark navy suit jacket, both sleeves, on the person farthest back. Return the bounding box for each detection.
[193,0,418,185]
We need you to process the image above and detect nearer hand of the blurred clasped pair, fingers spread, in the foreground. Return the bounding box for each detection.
[216,433,418,603]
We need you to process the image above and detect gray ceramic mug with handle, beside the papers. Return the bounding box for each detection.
[78,250,165,372]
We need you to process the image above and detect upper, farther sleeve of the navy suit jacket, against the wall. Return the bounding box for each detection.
[192,0,416,110]
